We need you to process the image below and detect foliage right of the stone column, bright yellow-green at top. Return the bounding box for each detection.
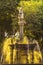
[20,1,43,37]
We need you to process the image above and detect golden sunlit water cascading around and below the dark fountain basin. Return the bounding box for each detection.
[1,37,42,64]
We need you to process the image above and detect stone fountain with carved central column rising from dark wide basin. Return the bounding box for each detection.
[1,7,39,64]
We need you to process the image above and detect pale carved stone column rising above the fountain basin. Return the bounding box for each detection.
[18,7,25,39]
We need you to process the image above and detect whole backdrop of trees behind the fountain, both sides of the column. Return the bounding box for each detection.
[0,0,43,49]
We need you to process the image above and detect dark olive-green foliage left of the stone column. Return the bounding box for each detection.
[0,0,19,40]
